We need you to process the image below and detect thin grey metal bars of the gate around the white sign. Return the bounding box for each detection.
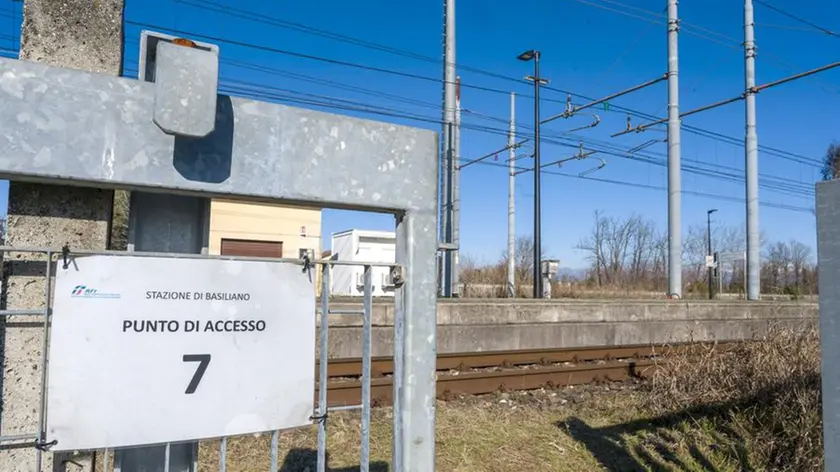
[0,246,402,472]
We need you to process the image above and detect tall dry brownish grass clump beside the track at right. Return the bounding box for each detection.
[646,328,822,471]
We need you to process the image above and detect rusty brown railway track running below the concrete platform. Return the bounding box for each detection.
[316,343,724,406]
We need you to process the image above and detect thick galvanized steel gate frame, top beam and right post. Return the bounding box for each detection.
[0,50,440,472]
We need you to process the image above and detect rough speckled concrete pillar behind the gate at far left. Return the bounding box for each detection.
[0,0,123,472]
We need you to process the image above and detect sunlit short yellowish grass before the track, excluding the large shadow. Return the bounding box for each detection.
[199,403,597,472]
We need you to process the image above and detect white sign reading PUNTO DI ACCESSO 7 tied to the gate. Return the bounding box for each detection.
[47,256,315,451]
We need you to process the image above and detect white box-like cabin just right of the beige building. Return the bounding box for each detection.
[330,229,397,297]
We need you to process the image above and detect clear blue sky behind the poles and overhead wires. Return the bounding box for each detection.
[0,0,840,267]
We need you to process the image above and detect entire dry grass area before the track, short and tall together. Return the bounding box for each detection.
[182,329,822,472]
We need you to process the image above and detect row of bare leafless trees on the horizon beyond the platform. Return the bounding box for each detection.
[462,211,818,296]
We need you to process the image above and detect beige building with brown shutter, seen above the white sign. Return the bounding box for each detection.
[209,200,321,258]
